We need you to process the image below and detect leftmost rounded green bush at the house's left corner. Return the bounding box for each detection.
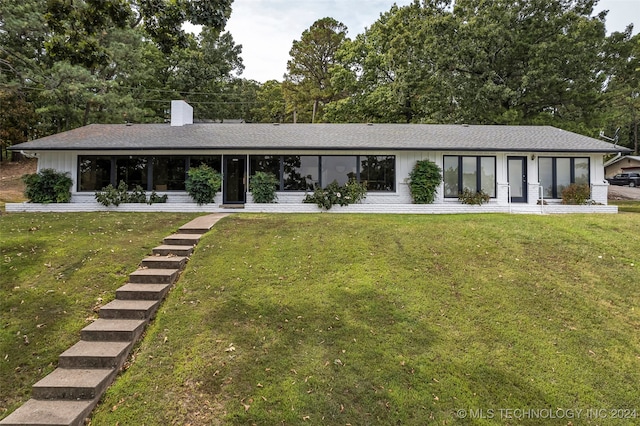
[22,169,73,204]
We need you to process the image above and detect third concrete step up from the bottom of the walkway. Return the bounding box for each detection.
[58,340,133,370]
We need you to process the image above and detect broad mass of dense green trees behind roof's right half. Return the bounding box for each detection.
[327,0,605,134]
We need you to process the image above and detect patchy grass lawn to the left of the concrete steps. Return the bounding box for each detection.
[0,213,200,418]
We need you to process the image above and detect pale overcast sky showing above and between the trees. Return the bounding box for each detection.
[221,0,640,83]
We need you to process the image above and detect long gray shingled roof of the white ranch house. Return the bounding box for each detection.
[11,124,629,153]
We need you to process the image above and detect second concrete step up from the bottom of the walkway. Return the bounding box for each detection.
[32,368,117,400]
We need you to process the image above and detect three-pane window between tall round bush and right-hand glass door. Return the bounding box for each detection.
[444,155,496,198]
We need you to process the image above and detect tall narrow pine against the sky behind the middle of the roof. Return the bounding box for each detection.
[283,18,347,123]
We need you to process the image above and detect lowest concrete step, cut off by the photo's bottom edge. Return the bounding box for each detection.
[0,398,98,426]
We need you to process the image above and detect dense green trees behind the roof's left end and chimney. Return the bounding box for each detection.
[0,0,242,146]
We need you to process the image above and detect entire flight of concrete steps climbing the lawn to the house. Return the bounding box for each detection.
[0,213,227,426]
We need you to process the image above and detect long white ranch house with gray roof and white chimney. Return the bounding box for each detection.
[6,101,629,213]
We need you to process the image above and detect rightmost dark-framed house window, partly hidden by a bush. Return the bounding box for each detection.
[538,157,591,198]
